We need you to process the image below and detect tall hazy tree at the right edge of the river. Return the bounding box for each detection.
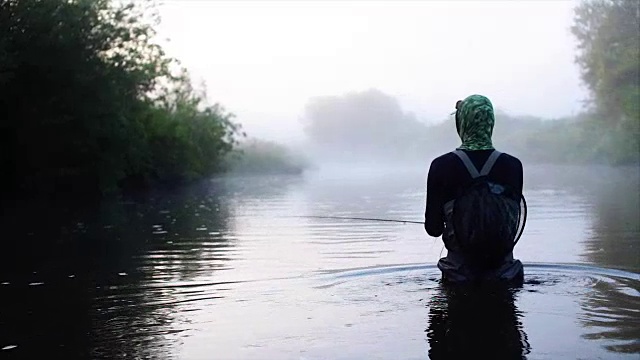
[572,0,640,163]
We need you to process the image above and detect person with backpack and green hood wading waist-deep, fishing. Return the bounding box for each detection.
[424,95,524,283]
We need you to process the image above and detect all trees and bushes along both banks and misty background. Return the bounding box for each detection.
[0,0,640,205]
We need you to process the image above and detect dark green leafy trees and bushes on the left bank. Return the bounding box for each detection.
[0,0,244,200]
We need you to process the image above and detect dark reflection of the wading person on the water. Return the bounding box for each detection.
[427,285,531,359]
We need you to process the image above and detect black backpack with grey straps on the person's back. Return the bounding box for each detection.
[452,150,526,268]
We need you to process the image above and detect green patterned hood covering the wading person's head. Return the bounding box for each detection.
[456,95,495,150]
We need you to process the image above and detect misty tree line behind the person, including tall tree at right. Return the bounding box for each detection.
[303,0,640,164]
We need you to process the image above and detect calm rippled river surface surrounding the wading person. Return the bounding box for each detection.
[0,166,640,359]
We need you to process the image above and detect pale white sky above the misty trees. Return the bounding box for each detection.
[157,0,587,142]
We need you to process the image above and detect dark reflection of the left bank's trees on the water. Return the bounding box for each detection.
[0,180,240,359]
